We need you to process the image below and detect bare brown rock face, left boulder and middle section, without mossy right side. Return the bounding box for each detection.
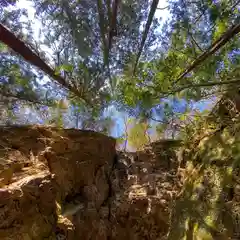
[0,126,181,240]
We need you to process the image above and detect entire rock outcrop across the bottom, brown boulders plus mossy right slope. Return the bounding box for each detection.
[0,94,240,240]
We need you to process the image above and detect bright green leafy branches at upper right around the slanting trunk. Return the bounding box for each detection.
[115,0,239,118]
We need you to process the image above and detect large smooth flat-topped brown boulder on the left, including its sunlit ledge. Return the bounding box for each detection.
[0,126,115,240]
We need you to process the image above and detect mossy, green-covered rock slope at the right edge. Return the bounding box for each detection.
[169,95,240,239]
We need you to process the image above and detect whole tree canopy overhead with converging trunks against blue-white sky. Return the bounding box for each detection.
[0,0,240,140]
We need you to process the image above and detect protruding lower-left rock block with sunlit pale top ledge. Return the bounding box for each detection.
[0,172,57,240]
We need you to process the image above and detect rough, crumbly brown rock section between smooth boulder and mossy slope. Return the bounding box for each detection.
[110,141,181,240]
